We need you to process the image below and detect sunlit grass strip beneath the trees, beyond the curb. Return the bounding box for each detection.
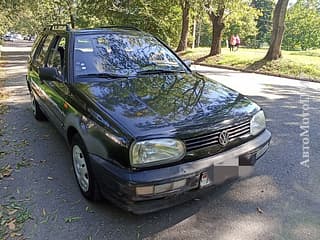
[179,48,320,81]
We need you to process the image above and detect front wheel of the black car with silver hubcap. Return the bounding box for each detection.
[71,134,101,201]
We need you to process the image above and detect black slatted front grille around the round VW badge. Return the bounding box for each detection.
[184,119,250,152]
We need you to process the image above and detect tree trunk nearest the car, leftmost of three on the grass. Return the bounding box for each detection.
[177,0,190,52]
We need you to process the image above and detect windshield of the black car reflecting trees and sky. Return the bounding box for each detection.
[74,33,186,76]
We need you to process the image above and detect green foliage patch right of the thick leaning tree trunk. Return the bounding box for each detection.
[283,0,320,50]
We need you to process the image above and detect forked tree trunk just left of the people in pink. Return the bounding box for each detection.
[209,7,225,56]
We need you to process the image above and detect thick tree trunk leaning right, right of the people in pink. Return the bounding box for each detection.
[264,0,289,61]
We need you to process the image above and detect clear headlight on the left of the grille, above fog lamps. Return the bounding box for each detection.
[130,138,186,167]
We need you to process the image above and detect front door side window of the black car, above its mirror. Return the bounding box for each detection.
[47,36,66,75]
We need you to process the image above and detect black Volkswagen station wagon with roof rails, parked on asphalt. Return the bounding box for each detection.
[27,25,271,213]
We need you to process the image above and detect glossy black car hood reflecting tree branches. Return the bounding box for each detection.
[76,73,259,139]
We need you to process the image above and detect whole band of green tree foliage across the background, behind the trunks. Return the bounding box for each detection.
[0,0,320,58]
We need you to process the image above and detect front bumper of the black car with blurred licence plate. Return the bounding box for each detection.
[90,130,271,214]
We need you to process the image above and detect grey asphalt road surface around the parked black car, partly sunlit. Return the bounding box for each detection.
[0,43,320,240]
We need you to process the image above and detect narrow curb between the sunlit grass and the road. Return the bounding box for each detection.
[194,63,320,83]
